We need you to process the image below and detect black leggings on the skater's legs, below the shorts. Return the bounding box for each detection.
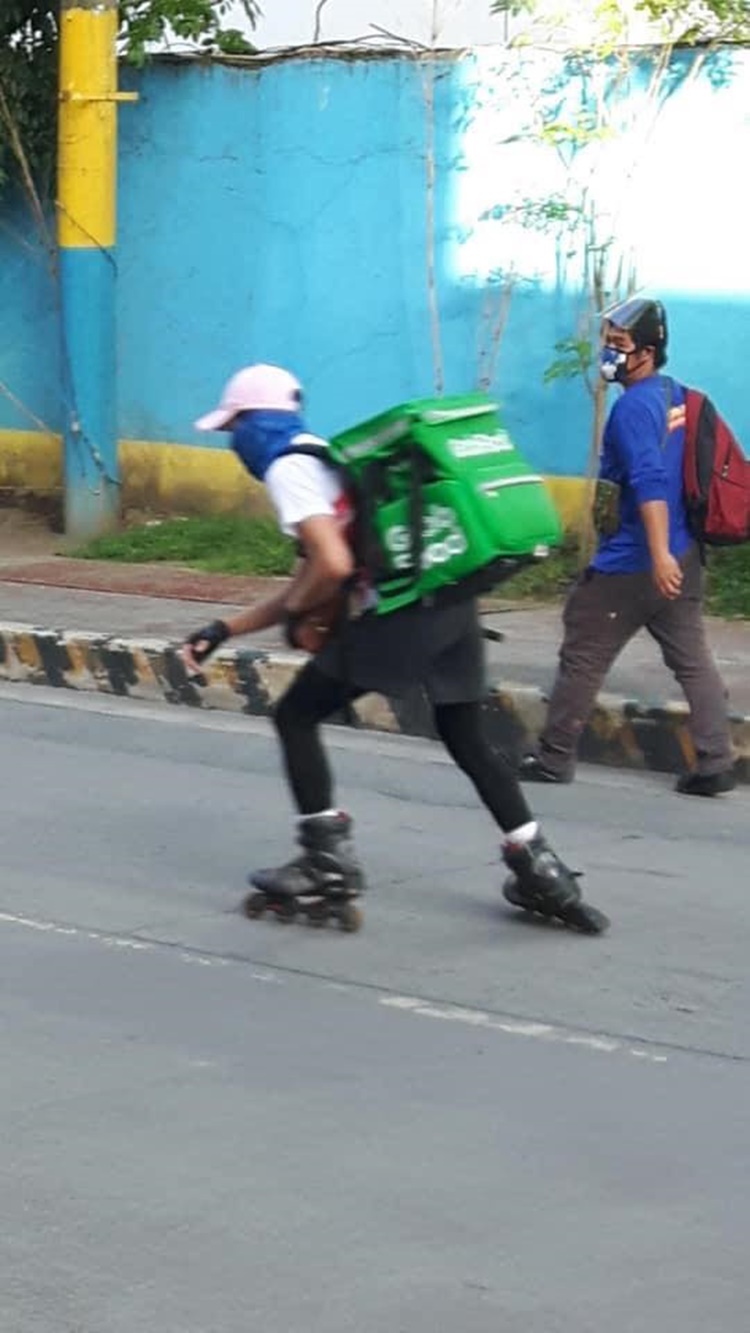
[274,663,533,832]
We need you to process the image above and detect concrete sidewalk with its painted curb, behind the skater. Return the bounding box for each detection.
[0,551,750,781]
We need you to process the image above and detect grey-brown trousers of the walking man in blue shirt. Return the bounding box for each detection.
[538,547,733,777]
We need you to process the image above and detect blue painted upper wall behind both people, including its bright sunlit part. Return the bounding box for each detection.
[0,52,750,473]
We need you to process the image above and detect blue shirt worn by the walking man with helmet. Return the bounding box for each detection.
[591,375,693,575]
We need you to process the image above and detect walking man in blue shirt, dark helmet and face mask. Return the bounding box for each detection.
[520,297,735,796]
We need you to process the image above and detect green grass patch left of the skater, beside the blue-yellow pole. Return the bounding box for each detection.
[72,515,294,577]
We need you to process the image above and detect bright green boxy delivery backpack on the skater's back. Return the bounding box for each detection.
[294,393,561,615]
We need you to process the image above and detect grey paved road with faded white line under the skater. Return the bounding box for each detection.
[0,686,750,1333]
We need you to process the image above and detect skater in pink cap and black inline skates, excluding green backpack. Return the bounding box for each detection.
[181,365,609,933]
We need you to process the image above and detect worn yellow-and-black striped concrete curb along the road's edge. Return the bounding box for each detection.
[0,624,750,782]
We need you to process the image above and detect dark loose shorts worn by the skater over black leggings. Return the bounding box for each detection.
[314,601,485,704]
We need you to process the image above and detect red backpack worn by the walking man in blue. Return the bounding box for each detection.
[683,389,750,547]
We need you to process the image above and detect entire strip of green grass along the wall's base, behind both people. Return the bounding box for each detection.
[73,515,750,619]
